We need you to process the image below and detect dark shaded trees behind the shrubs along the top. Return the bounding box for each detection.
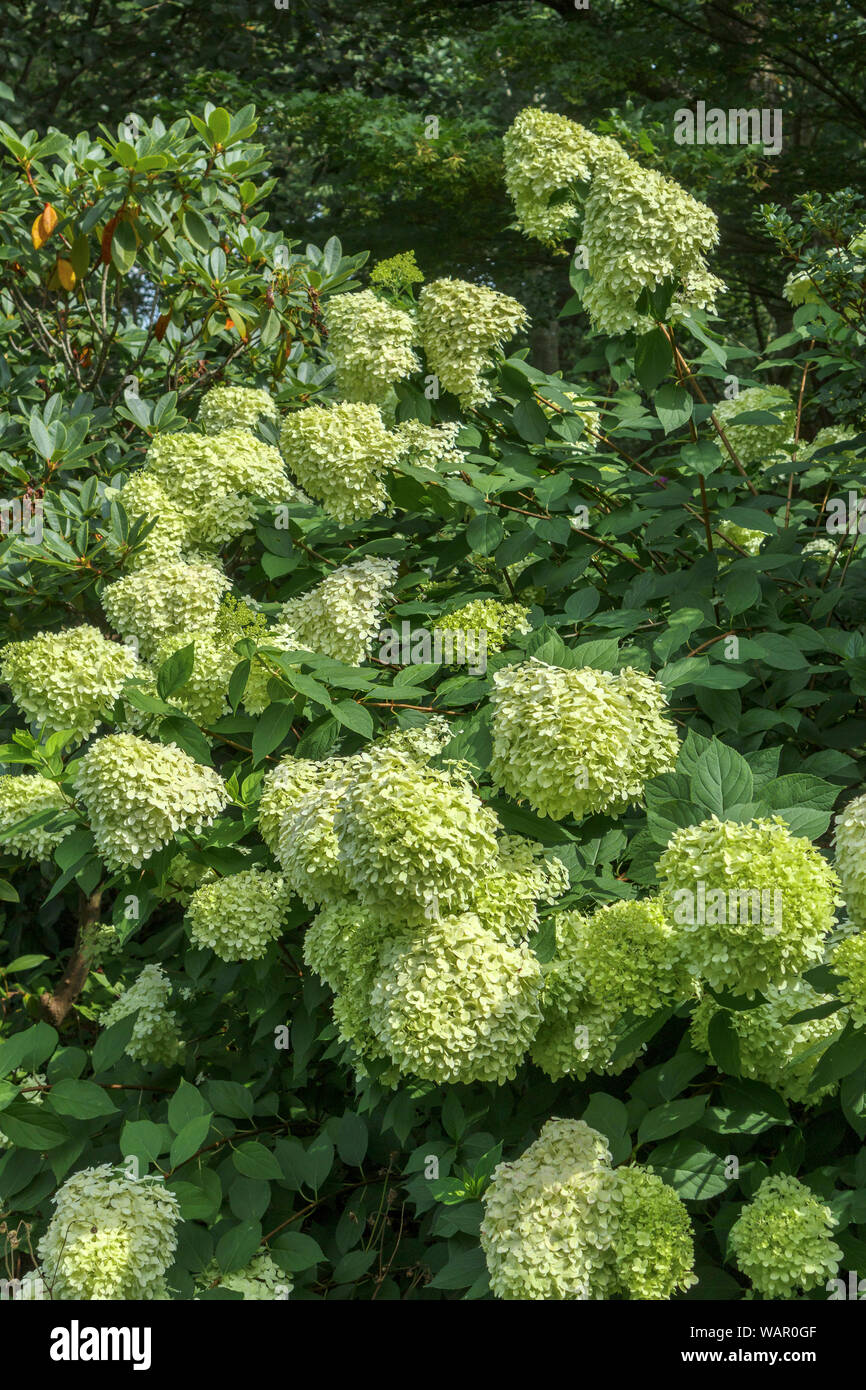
[0,0,866,371]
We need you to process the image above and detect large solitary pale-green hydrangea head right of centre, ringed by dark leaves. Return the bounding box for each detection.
[491,660,678,820]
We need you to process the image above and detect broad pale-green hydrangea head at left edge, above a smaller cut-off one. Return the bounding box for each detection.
[0,623,138,742]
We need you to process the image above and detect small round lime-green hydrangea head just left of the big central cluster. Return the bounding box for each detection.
[186,867,289,960]
